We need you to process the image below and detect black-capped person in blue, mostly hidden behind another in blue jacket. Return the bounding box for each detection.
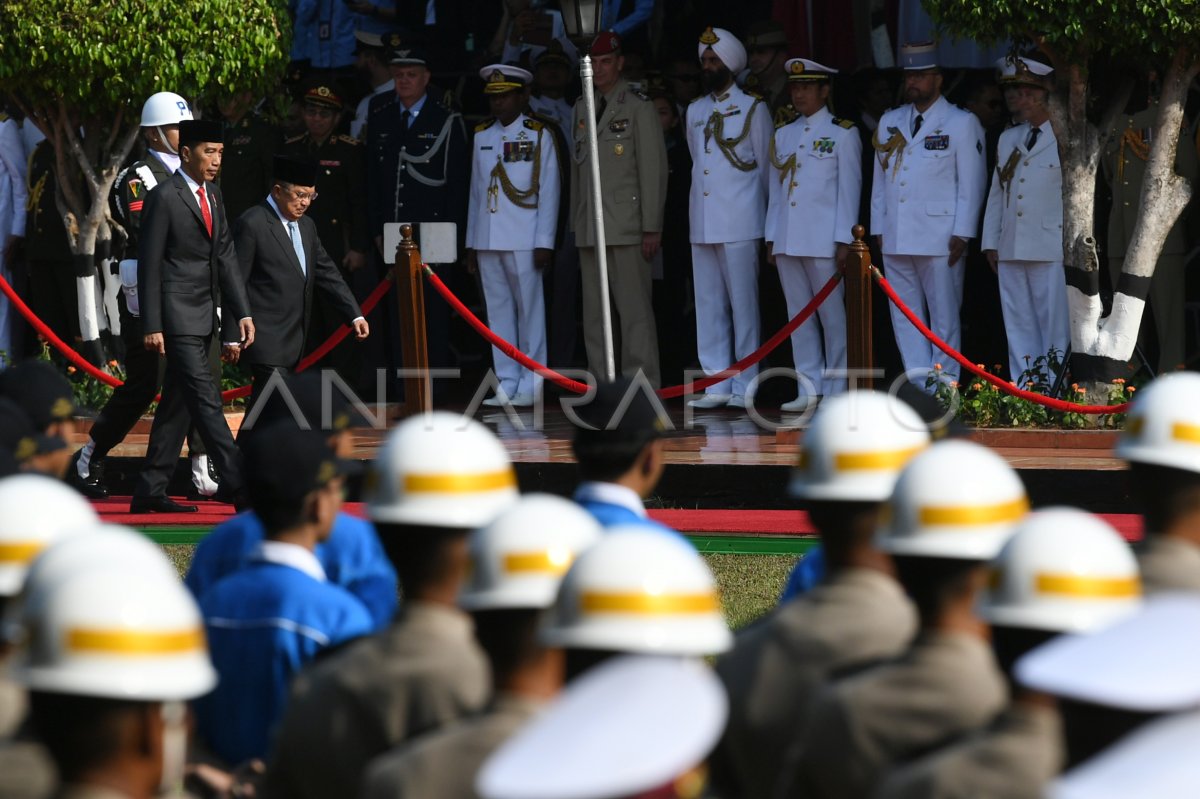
[184,374,398,629]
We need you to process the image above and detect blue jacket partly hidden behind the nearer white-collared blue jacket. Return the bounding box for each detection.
[184,511,397,630]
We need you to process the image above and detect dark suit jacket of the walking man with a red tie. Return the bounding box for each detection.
[138,172,250,341]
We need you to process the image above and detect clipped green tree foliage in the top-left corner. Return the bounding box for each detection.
[0,0,292,119]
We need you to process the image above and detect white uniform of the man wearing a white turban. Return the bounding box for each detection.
[686,84,772,397]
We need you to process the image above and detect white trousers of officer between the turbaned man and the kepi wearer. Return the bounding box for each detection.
[775,254,846,397]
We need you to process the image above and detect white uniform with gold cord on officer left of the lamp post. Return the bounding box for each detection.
[467,114,560,398]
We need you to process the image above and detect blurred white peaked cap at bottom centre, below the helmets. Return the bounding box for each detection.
[473,655,728,799]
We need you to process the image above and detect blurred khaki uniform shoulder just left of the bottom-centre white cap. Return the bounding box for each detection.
[361,695,545,799]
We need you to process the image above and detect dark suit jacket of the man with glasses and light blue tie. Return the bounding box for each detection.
[234,202,362,367]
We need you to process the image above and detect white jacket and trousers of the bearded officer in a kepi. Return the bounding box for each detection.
[871,97,988,386]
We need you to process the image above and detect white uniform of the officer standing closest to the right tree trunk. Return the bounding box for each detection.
[982,120,1070,380]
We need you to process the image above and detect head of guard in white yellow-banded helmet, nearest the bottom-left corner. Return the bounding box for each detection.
[13,544,216,797]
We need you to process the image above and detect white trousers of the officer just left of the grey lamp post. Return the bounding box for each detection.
[476,250,546,397]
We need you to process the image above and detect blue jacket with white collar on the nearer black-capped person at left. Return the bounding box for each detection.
[196,541,372,765]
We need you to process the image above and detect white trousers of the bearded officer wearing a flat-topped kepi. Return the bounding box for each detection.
[883,253,967,389]
